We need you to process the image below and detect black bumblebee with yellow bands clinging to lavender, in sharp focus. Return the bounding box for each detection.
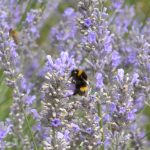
[70,69,88,95]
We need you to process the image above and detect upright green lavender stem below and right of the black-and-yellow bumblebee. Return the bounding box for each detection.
[97,102,104,150]
